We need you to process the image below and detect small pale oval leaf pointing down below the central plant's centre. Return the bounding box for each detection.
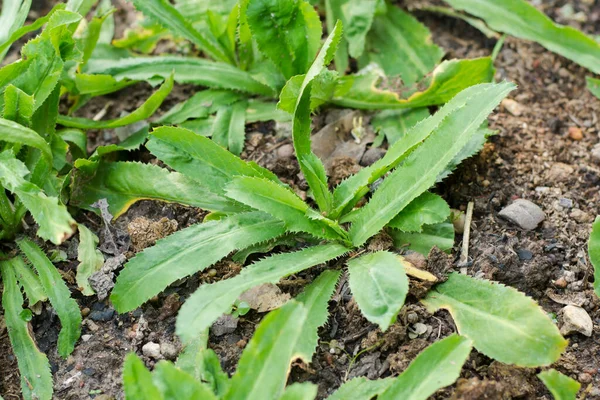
[348,251,408,331]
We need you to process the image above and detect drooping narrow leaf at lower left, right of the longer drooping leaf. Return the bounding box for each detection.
[17,239,81,358]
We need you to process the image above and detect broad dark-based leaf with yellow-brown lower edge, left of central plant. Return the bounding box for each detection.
[70,162,239,218]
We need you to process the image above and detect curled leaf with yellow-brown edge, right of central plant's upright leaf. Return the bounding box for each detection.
[332,57,495,110]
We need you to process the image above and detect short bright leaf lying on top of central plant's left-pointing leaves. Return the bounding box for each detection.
[225,176,343,239]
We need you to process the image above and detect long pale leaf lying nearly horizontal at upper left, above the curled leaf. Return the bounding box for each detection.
[87,56,274,96]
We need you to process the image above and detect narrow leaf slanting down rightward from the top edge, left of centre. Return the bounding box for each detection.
[133,0,233,63]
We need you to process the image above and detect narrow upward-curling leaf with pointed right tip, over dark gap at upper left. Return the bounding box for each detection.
[58,76,173,129]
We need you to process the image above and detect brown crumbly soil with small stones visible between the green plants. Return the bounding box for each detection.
[0,1,600,400]
